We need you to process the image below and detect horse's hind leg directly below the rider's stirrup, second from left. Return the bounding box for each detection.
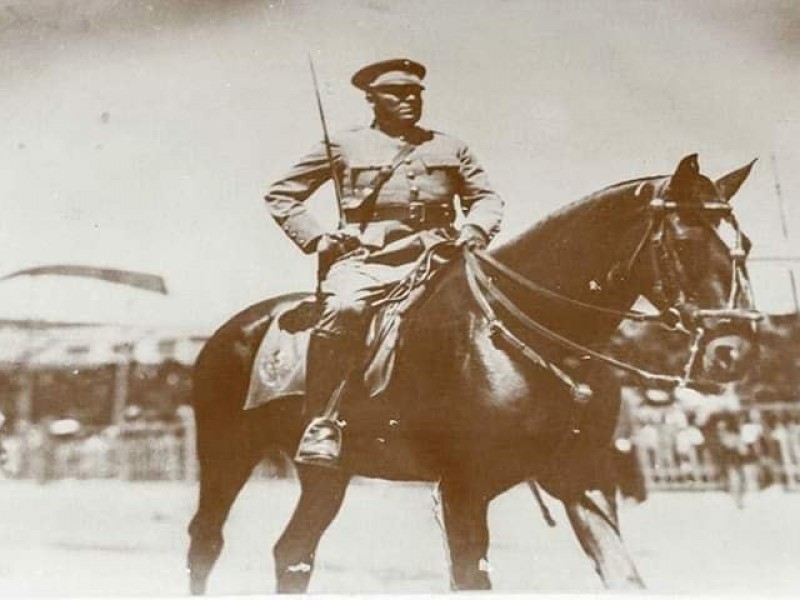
[273,467,350,593]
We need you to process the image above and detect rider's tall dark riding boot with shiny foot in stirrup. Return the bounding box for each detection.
[294,334,355,467]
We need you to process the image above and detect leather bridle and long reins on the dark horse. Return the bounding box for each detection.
[464,182,762,402]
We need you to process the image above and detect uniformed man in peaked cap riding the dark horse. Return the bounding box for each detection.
[266,59,503,465]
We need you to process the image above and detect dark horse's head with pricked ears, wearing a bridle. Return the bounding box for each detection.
[642,154,760,382]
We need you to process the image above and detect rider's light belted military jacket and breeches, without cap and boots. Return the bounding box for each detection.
[266,127,503,334]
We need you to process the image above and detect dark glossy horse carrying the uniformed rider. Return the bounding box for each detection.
[188,154,755,595]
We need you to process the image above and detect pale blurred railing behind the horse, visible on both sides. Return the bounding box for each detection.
[4,404,800,491]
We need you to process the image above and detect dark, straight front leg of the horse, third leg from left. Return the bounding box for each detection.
[437,479,492,591]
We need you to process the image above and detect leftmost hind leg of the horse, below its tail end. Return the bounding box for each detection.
[187,446,259,596]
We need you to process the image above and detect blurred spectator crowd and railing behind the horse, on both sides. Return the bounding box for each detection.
[0,316,800,492]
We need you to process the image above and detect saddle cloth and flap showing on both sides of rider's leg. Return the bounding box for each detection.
[244,242,454,410]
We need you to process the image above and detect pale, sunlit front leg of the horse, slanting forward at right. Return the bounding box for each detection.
[564,490,644,589]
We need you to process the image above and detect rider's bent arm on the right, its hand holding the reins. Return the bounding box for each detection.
[457,144,504,240]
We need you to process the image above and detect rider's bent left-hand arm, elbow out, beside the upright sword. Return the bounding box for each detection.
[264,143,341,253]
